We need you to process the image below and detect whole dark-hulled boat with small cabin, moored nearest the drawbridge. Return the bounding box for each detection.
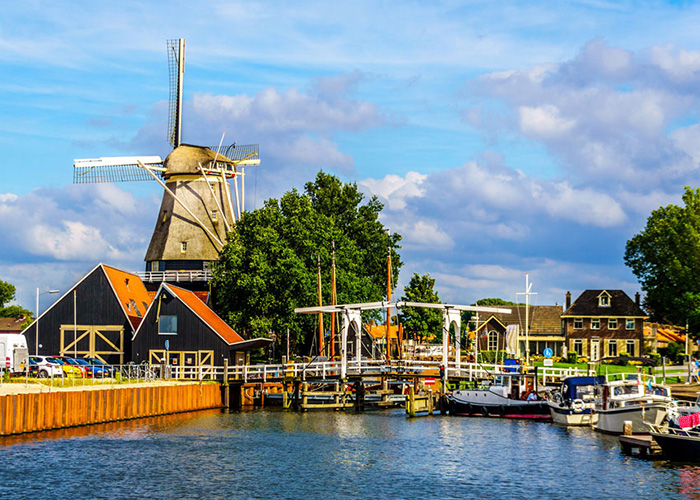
[447,373,552,420]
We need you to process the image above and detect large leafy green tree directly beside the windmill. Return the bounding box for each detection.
[212,172,401,353]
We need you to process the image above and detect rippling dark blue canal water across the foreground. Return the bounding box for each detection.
[0,410,700,500]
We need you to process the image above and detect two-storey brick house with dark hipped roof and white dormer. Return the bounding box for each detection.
[561,290,648,360]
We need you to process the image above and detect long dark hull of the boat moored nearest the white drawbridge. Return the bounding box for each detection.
[449,390,552,420]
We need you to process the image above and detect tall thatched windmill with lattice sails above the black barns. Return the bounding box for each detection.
[73,39,260,290]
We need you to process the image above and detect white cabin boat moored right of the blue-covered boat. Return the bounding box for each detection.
[593,375,673,434]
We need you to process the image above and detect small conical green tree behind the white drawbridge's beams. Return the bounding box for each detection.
[399,273,442,342]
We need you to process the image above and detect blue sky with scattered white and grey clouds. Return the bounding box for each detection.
[0,0,700,309]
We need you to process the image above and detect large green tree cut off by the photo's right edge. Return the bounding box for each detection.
[625,186,700,331]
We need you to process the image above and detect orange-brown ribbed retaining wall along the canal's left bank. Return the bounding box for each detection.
[0,384,223,436]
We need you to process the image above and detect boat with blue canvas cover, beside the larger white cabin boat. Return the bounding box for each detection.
[547,377,605,426]
